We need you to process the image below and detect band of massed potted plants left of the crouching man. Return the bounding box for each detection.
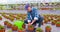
[0,13,26,21]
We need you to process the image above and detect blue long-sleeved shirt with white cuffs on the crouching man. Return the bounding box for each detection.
[27,8,39,22]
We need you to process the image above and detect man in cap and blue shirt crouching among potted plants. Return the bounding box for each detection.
[25,4,43,27]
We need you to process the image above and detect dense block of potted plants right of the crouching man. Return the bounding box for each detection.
[43,14,60,27]
